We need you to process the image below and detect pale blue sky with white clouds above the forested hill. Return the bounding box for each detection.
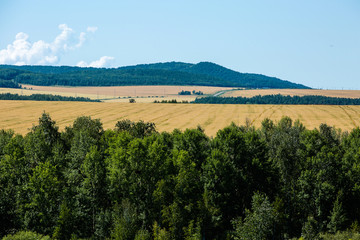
[0,0,360,90]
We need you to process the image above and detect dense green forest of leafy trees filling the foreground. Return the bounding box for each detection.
[0,113,360,240]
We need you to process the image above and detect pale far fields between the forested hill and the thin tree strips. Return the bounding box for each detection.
[0,85,360,103]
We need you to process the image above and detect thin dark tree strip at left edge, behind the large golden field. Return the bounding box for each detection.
[0,93,100,102]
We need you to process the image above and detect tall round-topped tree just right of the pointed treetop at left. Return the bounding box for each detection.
[62,117,109,238]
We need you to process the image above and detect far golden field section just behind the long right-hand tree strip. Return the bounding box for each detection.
[221,89,360,98]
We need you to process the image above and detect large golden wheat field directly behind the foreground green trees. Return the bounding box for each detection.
[0,101,360,136]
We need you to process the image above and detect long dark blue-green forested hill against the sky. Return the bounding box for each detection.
[0,62,309,89]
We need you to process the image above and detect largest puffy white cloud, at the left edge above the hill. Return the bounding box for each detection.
[0,24,97,65]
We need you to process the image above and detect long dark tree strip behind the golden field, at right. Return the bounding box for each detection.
[193,94,360,105]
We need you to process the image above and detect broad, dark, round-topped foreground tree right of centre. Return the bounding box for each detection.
[204,124,271,237]
